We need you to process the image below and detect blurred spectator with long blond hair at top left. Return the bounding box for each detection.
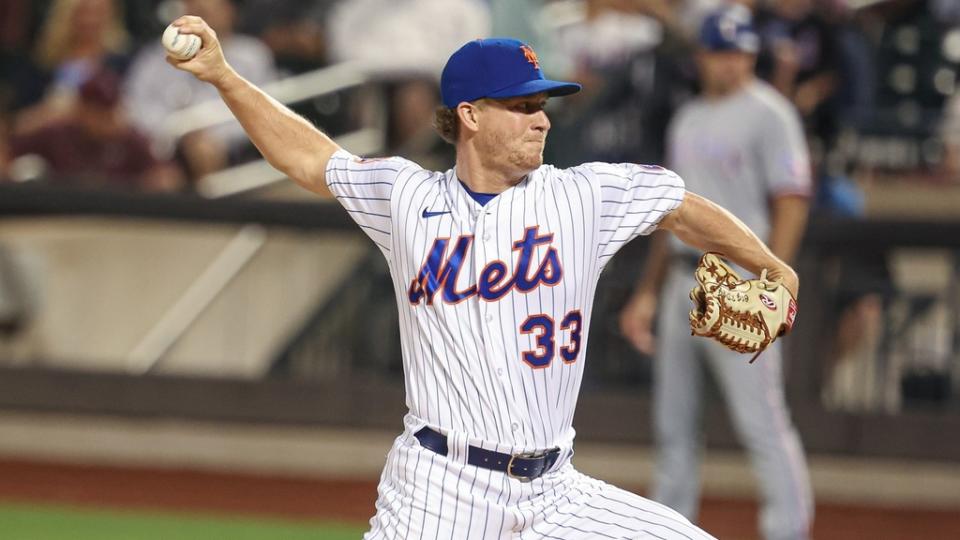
[12,0,129,133]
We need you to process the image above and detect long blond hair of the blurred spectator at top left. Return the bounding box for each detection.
[36,0,129,69]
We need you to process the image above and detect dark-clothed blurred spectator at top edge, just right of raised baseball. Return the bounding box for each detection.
[239,0,336,73]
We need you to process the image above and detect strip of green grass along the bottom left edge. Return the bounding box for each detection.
[0,504,366,540]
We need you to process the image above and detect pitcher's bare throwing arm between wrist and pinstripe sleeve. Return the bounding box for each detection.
[215,69,339,195]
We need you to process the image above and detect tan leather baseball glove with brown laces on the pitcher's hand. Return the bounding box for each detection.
[690,253,797,363]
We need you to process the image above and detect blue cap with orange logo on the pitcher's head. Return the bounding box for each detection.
[440,38,580,109]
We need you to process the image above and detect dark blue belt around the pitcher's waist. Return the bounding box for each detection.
[413,427,560,482]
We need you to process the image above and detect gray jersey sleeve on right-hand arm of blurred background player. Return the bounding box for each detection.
[759,102,812,197]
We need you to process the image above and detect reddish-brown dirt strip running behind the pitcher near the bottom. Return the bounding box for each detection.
[0,460,960,540]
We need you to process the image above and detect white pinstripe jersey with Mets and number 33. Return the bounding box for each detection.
[326,150,684,452]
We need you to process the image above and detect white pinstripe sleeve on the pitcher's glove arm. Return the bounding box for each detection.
[583,163,686,264]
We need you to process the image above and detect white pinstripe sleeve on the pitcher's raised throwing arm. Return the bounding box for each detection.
[326,150,420,251]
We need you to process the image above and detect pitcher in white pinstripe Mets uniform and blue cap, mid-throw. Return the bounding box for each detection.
[169,16,798,539]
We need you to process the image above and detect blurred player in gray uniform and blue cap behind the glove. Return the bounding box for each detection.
[620,6,813,540]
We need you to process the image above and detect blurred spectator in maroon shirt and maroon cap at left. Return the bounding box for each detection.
[9,70,180,191]
